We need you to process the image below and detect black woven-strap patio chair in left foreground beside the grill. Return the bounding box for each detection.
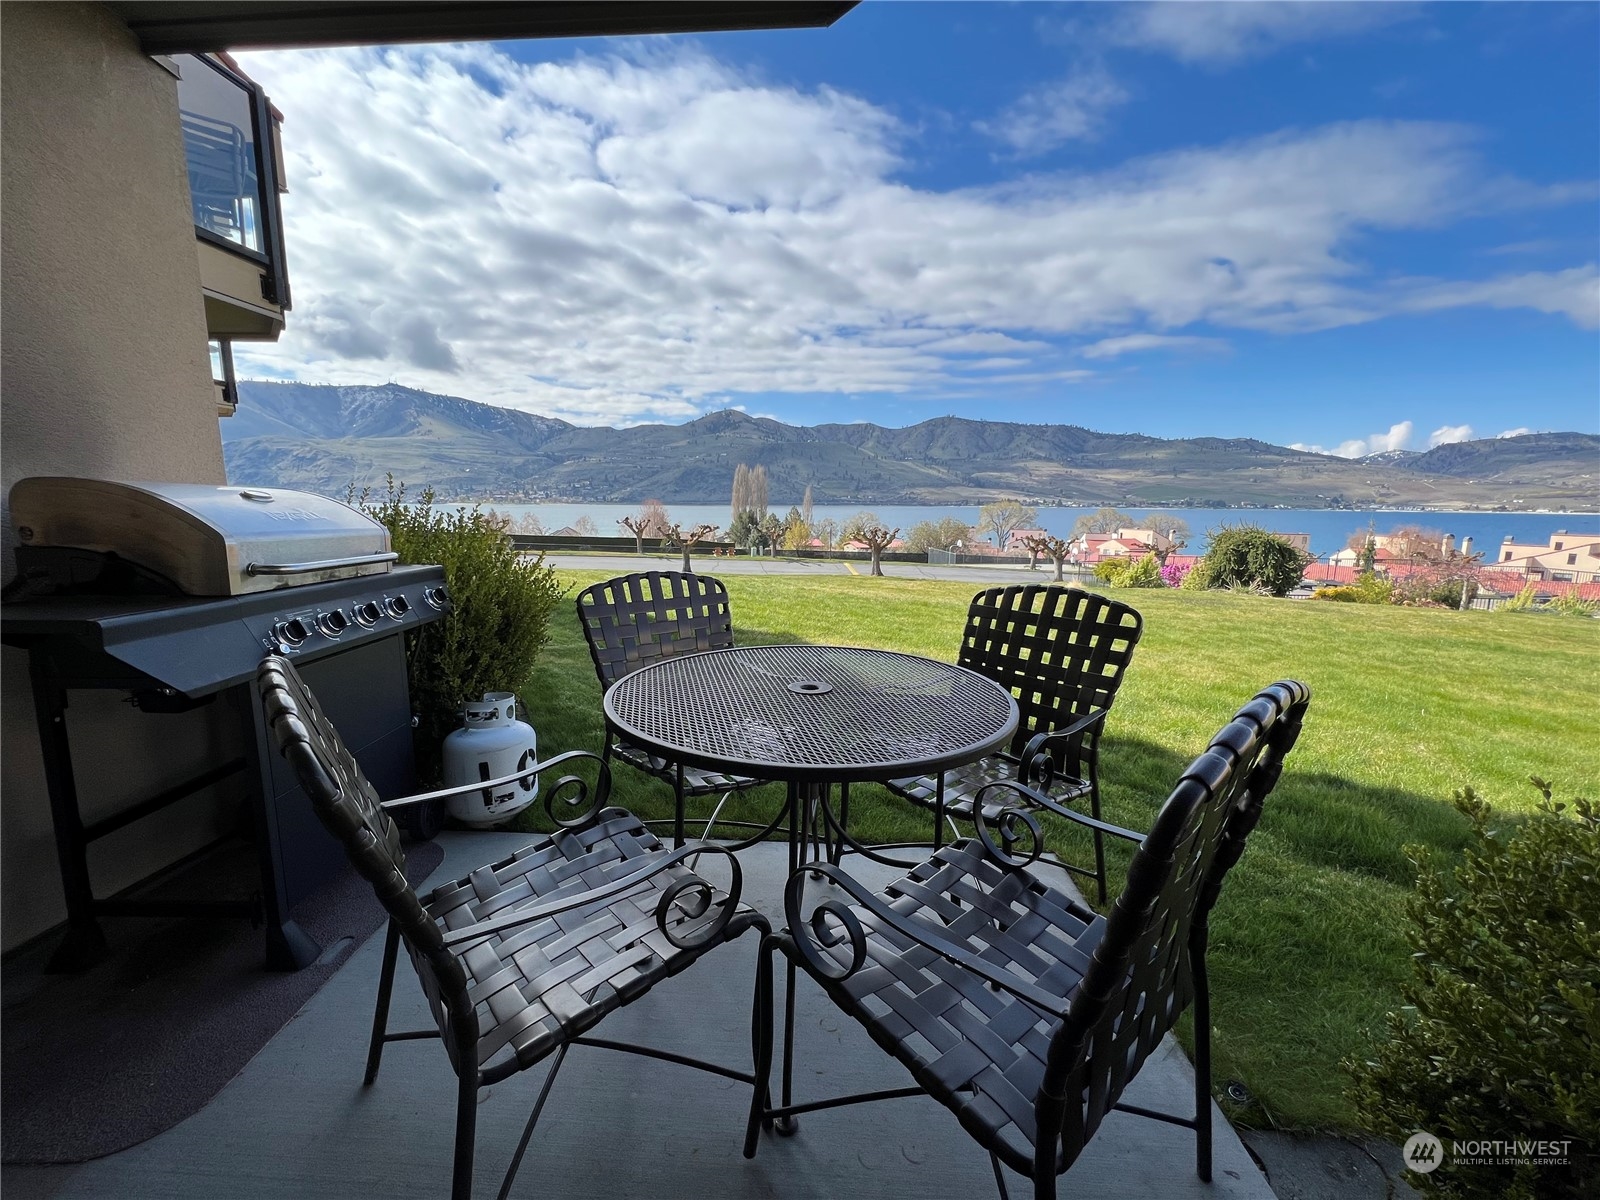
[256,656,771,1200]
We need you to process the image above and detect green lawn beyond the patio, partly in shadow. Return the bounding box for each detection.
[523,571,1600,1128]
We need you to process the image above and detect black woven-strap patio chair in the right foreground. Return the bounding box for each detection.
[744,680,1310,1198]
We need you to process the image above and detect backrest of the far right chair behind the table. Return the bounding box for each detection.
[957,584,1144,752]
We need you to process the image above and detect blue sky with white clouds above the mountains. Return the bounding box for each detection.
[238,0,1600,454]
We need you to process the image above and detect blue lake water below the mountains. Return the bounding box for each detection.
[467,504,1600,560]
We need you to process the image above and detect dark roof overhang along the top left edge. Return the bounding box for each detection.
[107,0,856,54]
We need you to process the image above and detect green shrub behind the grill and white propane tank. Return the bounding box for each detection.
[357,477,566,779]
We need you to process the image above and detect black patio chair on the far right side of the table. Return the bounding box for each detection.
[869,584,1144,904]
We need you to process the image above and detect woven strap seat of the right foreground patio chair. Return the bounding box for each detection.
[796,840,1106,1173]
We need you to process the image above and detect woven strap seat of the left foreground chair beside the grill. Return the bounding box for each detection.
[424,808,744,1080]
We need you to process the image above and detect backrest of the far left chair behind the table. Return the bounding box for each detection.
[578,571,733,688]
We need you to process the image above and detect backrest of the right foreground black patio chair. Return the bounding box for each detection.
[1040,680,1310,1163]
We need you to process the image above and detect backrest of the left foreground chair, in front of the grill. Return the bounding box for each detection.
[256,654,478,1070]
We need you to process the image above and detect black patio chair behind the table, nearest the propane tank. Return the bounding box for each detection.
[578,571,782,848]
